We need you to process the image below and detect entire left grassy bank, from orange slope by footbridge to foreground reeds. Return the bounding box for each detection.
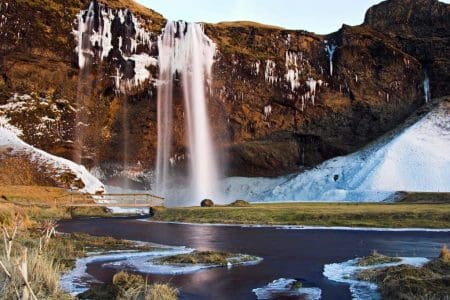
[0,186,178,300]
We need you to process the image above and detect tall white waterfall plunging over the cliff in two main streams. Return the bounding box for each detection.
[156,21,218,202]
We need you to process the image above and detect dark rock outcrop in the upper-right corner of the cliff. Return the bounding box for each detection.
[364,0,450,97]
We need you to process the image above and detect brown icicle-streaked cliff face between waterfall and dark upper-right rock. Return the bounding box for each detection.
[207,24,424,176]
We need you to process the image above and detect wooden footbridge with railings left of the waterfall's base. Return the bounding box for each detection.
[55,193,164,208]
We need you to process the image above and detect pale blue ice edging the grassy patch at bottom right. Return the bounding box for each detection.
[323,257,429,300]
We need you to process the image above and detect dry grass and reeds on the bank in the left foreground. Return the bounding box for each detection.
[0,216,178,300]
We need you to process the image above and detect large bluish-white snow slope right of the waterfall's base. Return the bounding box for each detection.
[224,101,450,201]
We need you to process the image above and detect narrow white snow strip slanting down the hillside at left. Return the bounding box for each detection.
[0,124,104,194]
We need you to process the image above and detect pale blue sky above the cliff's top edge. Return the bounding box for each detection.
[137,0,450,34]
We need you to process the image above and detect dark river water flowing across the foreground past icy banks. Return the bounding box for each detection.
[58,219,450,299]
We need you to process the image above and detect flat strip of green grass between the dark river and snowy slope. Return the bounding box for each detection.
[154,203,450,228]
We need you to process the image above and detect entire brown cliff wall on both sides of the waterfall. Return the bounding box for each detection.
[0,0,449,183]
